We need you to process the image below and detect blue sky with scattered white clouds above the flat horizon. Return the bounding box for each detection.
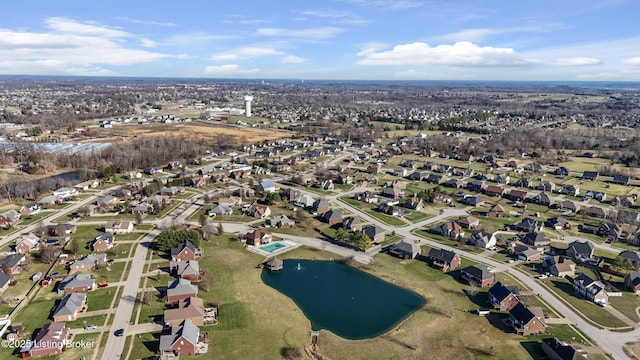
[0,0,640,81]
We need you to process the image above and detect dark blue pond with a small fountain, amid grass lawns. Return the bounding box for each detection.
[262,260,426,340]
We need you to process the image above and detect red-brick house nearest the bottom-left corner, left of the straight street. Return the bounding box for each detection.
[20,322,73,359]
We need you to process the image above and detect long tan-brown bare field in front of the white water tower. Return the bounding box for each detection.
[90,121,290,143]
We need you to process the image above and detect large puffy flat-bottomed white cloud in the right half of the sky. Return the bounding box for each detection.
[357,41,531,67]
